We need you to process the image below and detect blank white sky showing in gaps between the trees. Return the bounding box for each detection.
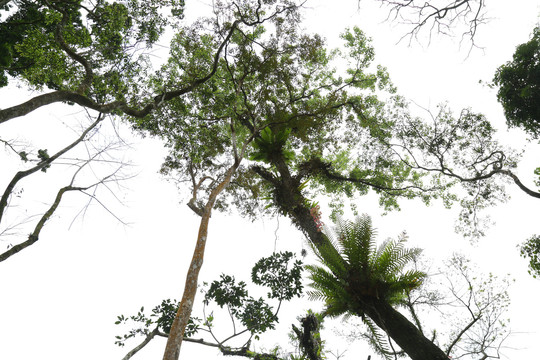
[0,0,540,360]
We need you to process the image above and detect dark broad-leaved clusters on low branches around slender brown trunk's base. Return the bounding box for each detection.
[115,252,302,346]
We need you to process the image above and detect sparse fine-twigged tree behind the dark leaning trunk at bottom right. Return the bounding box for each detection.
[340,254,510,360]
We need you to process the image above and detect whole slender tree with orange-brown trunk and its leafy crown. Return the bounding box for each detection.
[127,1,304,360]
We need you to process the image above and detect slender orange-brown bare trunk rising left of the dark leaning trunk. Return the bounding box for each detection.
[163,162,239,360]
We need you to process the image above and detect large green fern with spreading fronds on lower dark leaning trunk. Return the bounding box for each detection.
[306,214,426,324]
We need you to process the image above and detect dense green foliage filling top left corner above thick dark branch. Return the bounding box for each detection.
[0,0,184,102]
